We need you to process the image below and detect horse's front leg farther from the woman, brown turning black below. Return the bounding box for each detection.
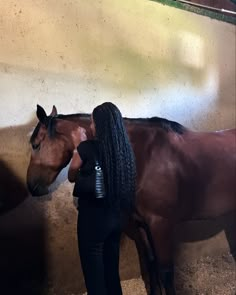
[149,216,176,295]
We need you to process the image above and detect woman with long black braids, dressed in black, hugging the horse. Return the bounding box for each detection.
[68,102,136,295]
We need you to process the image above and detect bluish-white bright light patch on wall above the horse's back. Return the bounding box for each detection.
[119,67,219,129]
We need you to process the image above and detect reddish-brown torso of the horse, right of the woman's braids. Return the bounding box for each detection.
[131,126,236,220]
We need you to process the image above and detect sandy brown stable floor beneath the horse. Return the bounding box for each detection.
[83,253,236,295]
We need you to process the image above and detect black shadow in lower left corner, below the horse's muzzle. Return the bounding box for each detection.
[0,206,47,295]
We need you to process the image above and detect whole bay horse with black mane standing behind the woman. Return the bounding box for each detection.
[27,106,236,295]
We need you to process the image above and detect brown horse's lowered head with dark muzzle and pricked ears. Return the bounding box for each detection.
[27,105,88,196]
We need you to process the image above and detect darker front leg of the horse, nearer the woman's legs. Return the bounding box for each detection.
[136,222,162,295]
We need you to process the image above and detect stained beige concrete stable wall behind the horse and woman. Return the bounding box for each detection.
[0,0,236,295]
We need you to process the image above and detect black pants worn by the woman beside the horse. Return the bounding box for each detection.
[77,202,122,295]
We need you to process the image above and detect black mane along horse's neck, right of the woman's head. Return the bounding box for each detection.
[124,117,187,134]
